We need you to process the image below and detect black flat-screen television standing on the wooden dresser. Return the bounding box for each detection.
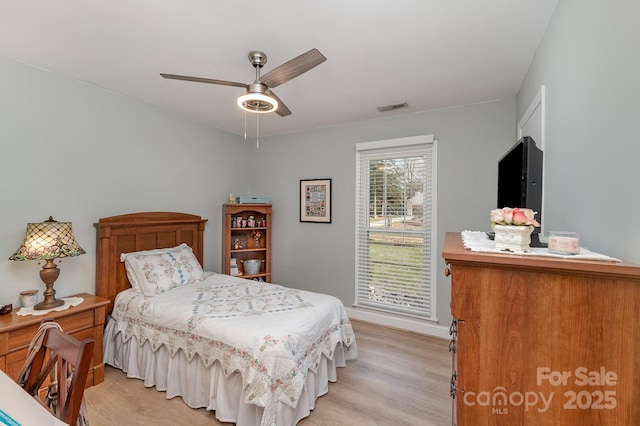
[498,136,542,246]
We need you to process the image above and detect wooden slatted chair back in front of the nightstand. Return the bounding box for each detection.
[23,328,95,425]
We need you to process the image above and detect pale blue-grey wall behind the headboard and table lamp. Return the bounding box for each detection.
[0,58,249,306]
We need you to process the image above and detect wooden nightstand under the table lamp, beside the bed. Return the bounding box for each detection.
[0,293,109,387]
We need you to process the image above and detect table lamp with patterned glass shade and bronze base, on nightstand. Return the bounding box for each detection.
[9,216,85,310]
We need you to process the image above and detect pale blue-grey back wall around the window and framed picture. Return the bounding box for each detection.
[252,99,515,326]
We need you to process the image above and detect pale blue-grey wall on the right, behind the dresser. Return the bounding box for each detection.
[517,0,640,263]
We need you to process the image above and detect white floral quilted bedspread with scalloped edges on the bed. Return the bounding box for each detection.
[105,273,357,424]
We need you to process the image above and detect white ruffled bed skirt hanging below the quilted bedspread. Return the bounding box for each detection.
[104,319,346,426]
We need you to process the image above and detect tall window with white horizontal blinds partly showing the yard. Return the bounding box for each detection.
[355,135,436,319]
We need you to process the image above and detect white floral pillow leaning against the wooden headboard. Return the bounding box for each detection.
[120,243,204,296]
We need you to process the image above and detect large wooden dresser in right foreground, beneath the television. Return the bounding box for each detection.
[442,233,640,426]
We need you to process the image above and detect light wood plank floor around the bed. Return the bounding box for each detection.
[85,321,451,426]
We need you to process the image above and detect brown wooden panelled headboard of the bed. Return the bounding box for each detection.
[95,212,207,313]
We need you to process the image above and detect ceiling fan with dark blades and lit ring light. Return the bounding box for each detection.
[160,49,327,117]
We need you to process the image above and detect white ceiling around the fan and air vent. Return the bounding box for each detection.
[0,0,557,136]
